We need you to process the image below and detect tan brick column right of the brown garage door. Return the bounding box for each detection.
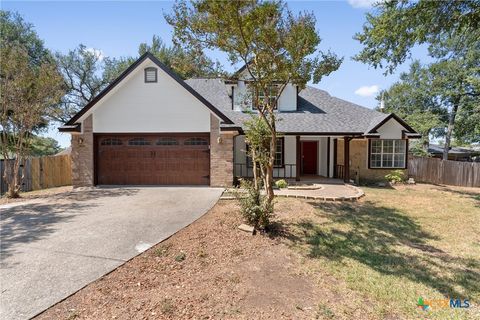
[210,115,235,187]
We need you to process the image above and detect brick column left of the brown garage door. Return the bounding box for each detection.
[71,115,95,187]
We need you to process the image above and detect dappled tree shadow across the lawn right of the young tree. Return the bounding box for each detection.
[279,201,480,298]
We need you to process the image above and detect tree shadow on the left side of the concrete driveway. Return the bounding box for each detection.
[0,189,138,268]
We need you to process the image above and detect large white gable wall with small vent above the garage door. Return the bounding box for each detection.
[81,59,211,132]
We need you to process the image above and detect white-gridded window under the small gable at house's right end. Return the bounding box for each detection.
[370,139,406,168]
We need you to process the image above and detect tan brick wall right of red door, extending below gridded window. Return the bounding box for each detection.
[337,139,407,182]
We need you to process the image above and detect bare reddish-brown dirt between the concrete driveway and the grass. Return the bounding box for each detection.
[38,199,376,319]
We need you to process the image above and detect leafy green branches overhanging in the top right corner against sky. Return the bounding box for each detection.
[354,0,480,72]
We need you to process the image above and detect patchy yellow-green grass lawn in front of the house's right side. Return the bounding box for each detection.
[282,186,480,319]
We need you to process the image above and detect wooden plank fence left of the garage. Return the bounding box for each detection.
[0,155,72,194]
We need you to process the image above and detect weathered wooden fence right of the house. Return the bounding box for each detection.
[408,157,480,187]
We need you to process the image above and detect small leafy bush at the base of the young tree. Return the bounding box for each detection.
[235,180,273,230]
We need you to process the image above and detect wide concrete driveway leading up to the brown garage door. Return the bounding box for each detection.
[0,187,222,319]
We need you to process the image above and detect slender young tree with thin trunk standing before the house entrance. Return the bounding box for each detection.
[166,0,341,203]
